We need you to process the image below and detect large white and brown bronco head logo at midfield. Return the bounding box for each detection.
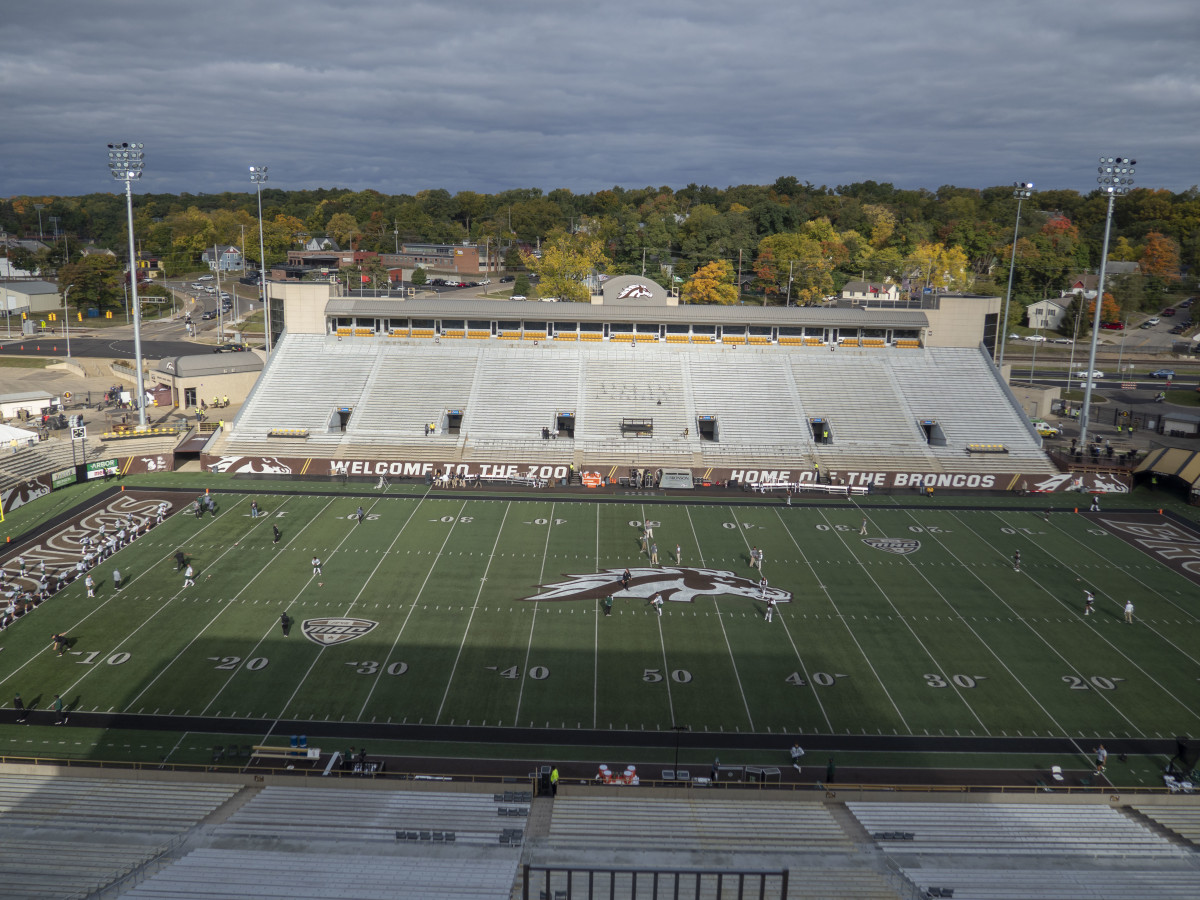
[521,566,792,604]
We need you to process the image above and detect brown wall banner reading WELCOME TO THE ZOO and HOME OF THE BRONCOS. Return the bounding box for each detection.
[202,454,1130,493]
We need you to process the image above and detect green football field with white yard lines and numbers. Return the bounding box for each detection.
[0,493,1200,738]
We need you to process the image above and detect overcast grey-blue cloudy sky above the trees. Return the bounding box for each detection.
[0,0,1200,196]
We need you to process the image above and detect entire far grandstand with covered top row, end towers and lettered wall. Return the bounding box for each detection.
[204,284,1080,491]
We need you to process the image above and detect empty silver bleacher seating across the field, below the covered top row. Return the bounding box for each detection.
[220,335,1055,475]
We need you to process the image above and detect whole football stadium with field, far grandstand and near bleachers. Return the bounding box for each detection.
[0,276,1200,900]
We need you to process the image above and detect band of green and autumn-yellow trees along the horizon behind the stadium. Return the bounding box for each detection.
[0,176,1200,322]
